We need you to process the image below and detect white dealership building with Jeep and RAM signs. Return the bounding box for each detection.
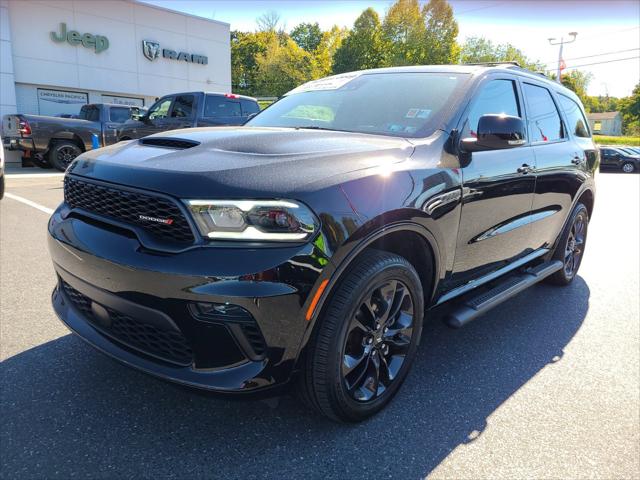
[0,0,231,161]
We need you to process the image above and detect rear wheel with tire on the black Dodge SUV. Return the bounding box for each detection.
[546,203,589,286]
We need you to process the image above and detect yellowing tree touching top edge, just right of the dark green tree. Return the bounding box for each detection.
[382,0,426,66]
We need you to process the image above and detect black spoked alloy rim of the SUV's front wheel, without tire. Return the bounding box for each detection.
[342,280,413,402]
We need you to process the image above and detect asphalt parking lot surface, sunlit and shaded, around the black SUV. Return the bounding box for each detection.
[0,173,640,479]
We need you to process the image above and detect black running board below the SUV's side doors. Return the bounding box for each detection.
[445,260,563,328]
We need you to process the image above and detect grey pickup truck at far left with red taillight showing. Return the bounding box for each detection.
[3,103,140,171]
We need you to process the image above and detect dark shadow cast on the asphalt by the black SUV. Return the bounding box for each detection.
[0,277,589,479]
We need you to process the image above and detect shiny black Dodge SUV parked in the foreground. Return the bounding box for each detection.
[49,65,598,421]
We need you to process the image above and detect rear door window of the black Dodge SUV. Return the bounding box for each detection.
[524,83,564,143]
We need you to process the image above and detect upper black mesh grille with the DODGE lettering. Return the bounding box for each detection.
[64,176,194,244]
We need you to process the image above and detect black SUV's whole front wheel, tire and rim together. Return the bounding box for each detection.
[298,250,424,422]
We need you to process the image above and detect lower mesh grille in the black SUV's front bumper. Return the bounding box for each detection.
[62,280,193,365]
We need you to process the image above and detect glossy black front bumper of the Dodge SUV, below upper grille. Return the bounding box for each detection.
[49,209,333,393]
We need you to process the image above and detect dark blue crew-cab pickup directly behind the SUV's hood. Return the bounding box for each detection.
[118,92,260,140]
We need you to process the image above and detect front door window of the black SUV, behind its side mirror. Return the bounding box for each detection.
[463,80,520,138]
